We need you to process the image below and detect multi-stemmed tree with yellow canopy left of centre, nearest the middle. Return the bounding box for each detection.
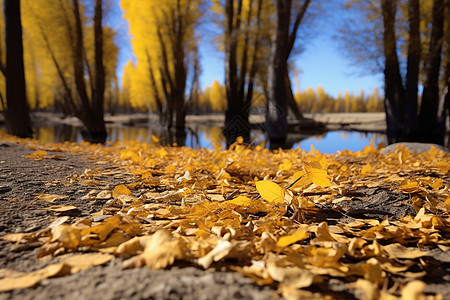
[120,0,203,129]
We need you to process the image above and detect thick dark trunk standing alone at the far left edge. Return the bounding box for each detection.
[3,0,33,137]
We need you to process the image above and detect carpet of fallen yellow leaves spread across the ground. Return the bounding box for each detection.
[0,137,450,299]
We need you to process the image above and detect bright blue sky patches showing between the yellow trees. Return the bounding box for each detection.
[110,0,383,96]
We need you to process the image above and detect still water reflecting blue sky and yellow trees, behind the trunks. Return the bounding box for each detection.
[2,124,386,153]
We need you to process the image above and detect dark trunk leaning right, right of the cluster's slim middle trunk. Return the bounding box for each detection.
[419,0,445,144]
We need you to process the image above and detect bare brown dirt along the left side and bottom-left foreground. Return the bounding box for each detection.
[0,142,277,300]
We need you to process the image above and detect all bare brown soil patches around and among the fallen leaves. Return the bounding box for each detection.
[0,142,450,300]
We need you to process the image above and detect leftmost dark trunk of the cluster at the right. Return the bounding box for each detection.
[381,0,405,144]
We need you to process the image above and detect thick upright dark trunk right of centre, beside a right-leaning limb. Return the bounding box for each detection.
[265,0,291,147]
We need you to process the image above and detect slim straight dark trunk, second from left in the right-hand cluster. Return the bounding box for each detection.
[405,0,421,139]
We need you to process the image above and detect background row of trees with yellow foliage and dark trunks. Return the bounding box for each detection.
[0,0,450,148]
